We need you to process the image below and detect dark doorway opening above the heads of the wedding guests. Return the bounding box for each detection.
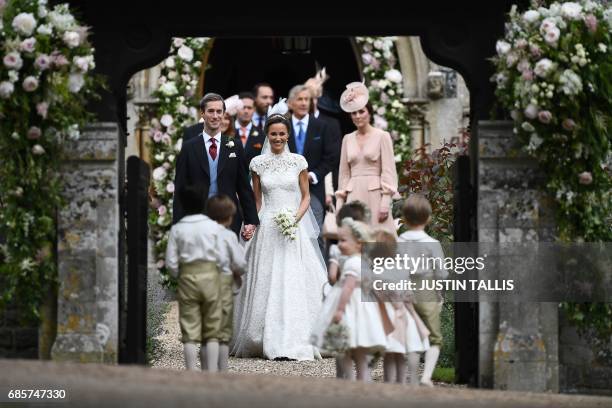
[204,37,361,134]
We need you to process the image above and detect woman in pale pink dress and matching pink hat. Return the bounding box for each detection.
[336,82,398,233]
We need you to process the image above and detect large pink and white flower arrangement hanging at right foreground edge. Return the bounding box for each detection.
[492,0,612,344]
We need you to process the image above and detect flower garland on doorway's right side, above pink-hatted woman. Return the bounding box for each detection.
[356,37,411,163]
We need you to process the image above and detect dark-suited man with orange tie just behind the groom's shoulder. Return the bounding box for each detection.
[234,92,266,167]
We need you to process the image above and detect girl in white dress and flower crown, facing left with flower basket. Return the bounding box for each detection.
[311,218,387,382]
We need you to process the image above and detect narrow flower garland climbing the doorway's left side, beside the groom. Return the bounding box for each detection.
[149,38,210,286]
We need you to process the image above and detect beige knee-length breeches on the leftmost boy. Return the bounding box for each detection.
[178,262,221,343]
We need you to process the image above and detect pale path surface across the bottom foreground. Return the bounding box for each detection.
[0,360,612,408]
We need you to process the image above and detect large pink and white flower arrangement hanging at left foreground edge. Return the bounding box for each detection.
[0,0,102,319]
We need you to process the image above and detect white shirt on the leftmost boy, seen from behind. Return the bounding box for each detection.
[166,214,225,277]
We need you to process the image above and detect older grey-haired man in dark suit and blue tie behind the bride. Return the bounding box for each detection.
[288,85,340,246]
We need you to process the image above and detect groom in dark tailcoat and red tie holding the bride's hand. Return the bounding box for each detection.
[173,93,259,239]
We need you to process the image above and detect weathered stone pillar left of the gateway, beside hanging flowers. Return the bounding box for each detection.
[51,122,120,363]
